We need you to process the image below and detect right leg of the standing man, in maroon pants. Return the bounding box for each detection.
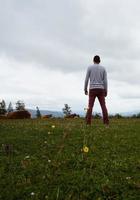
[98,92,109,125]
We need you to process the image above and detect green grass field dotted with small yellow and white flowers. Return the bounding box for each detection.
[0,119,140,200]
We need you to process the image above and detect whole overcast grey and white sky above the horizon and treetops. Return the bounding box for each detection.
[0,0,140,113]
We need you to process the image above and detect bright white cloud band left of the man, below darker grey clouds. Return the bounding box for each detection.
[0,54,87,110]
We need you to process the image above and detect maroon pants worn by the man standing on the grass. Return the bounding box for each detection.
[86,89,109,124]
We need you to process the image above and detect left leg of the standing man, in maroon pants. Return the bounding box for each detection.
[86,90,96,124]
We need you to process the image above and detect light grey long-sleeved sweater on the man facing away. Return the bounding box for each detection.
[84,64,107,92]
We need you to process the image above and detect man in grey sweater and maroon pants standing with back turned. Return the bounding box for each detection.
[84,55,109,125]
